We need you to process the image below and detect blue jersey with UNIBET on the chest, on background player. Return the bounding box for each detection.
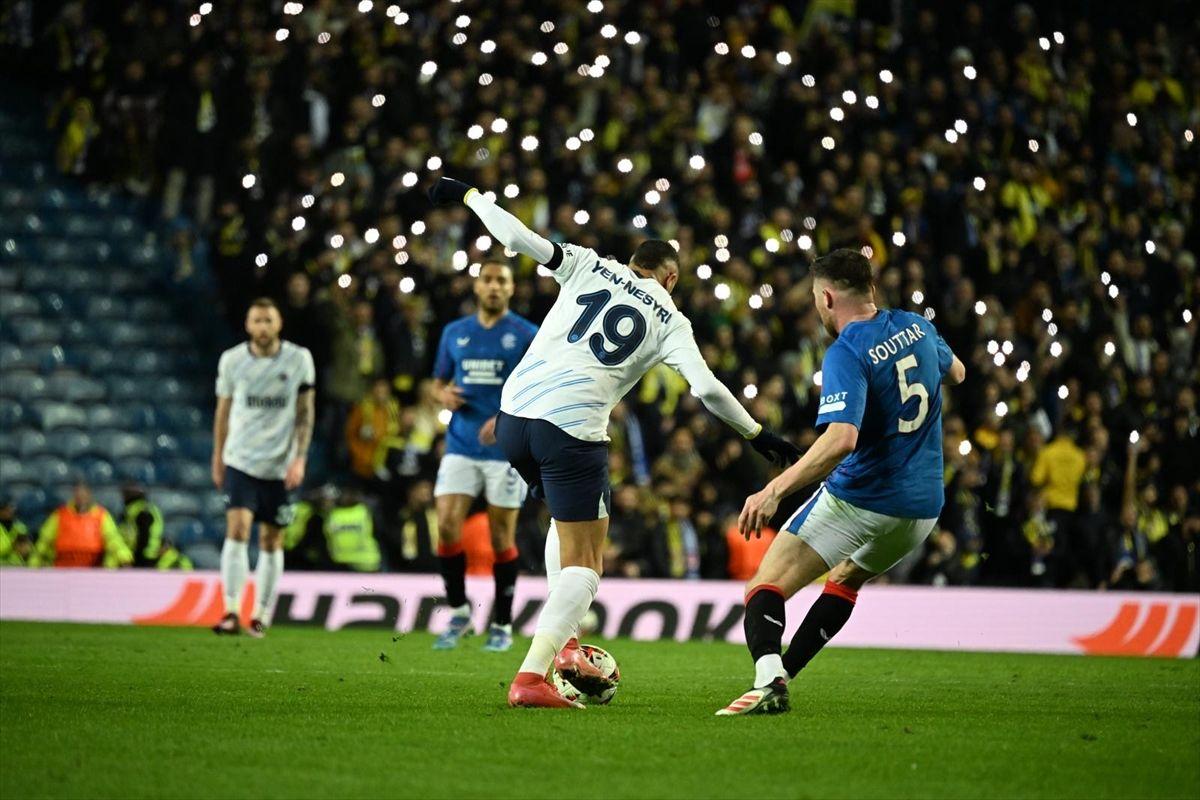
[433,312,538,461]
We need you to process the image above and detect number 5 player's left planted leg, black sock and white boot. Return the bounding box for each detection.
[716,534,829,716]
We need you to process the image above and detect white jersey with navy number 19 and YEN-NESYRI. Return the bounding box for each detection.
[500,245,729,441]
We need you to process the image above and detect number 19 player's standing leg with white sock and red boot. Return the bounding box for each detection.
[509,518,608,708]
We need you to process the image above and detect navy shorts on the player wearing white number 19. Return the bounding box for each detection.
[496,411,612,522]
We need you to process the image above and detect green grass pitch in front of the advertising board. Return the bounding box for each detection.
[0,622,1200,800]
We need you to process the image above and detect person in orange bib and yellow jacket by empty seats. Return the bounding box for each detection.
[36,482,133,567]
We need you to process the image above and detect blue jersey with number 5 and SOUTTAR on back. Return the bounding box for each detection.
[817,309,954,519]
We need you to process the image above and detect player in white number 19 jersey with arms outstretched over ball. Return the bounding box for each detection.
[430,178,799,708]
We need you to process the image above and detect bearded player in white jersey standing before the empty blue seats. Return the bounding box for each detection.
[212,297,317,637]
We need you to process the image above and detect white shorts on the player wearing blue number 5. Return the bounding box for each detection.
[784,483,937,575]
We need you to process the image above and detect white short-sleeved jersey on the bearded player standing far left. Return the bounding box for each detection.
[217,342,317,480]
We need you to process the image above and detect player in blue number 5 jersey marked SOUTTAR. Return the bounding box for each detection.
[716,249,966,716]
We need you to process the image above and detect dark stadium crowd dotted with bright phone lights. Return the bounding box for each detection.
[7,0,1200,591]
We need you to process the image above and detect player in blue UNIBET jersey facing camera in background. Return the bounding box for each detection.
[433,261,538,652]
